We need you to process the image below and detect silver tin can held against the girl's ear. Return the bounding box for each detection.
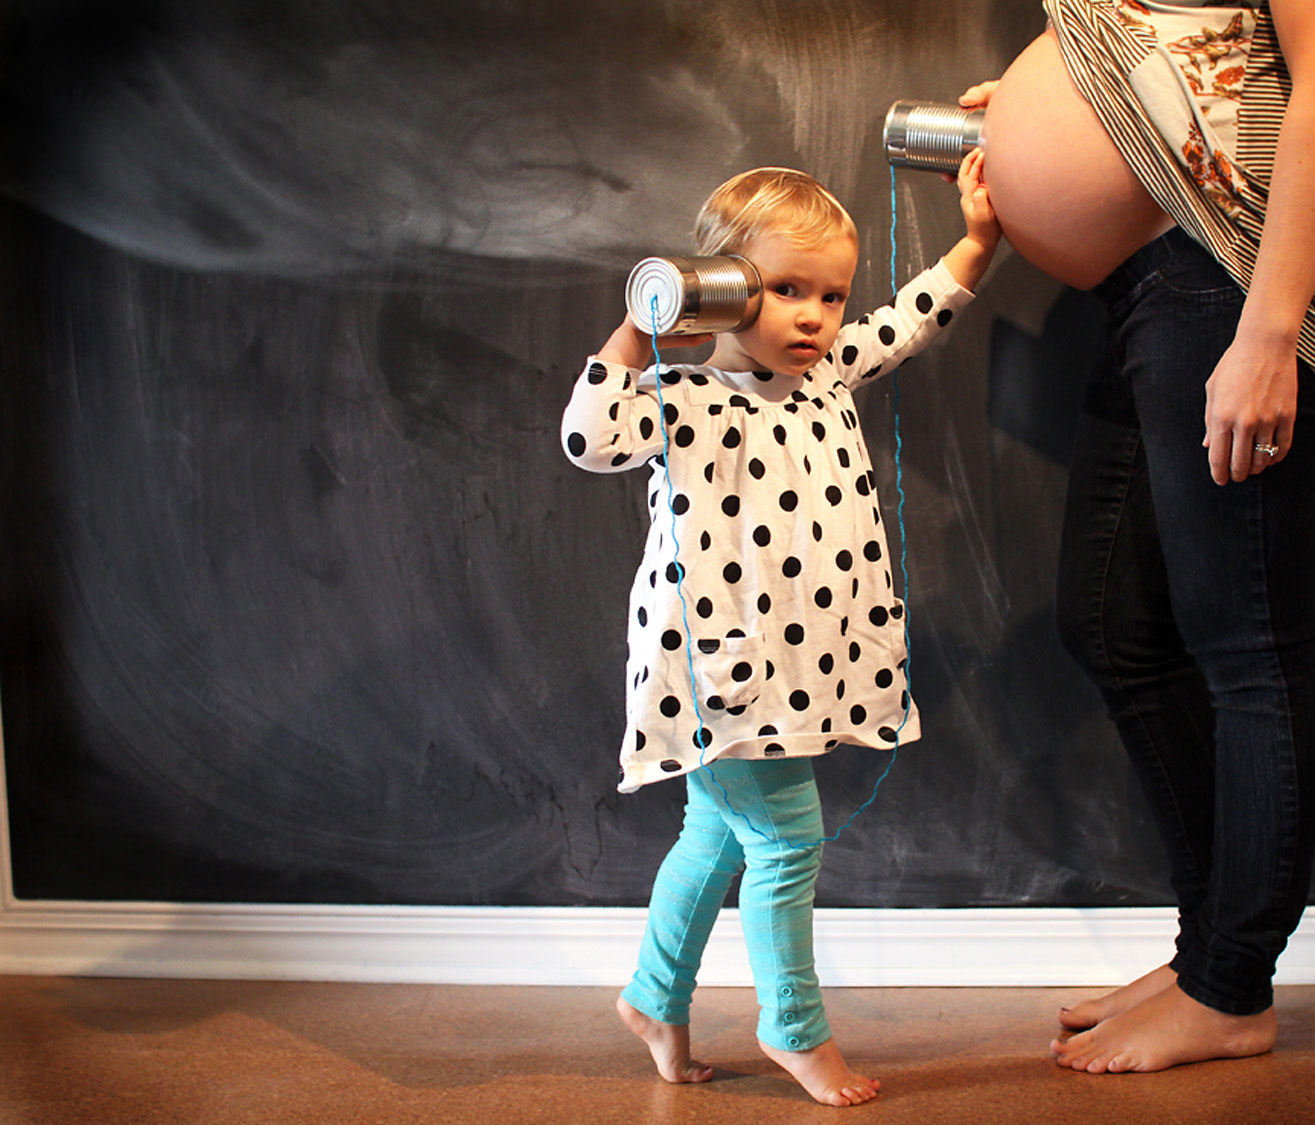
[626,254,763,336]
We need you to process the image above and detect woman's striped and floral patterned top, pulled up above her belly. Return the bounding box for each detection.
[1044,0,1315,364]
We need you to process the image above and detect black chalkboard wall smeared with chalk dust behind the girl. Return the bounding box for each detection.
[0,0,1194,907]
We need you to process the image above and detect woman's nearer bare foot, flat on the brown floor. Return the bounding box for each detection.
[1051,986,1278,1074]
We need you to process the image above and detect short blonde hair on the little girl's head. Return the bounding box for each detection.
[694,168,859,255]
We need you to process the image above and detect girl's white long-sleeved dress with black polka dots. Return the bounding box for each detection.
[562,263,972,792]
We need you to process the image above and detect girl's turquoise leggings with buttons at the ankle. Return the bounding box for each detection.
[621,758,831,1051]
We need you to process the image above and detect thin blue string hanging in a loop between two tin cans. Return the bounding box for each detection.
[651,166,913,849]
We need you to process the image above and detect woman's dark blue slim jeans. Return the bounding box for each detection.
[1057,229,1315,1015]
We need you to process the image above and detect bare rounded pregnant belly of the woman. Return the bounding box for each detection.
[985,33,1173,289]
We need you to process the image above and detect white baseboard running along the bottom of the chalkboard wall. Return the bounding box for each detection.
[0,895,1315,987]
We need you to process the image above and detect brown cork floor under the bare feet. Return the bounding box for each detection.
[0,976,1315,1125]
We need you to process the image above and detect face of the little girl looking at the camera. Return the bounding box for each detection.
[709,233,859,375]
